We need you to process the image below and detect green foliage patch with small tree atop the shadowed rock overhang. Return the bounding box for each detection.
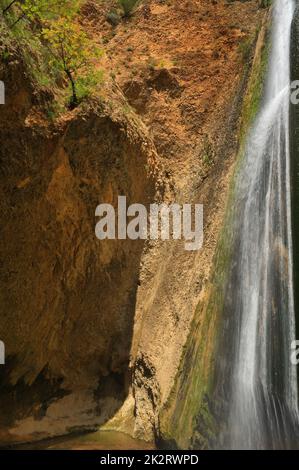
[0,0,103,108]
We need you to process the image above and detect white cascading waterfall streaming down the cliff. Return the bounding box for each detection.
[217,0,298,449]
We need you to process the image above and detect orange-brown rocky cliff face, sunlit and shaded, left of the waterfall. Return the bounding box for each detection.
[0,0,263,443]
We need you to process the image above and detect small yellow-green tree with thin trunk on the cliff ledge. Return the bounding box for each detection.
[42,17,102,108]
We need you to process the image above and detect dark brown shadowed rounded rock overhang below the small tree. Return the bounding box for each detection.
[0,49,162,440]
